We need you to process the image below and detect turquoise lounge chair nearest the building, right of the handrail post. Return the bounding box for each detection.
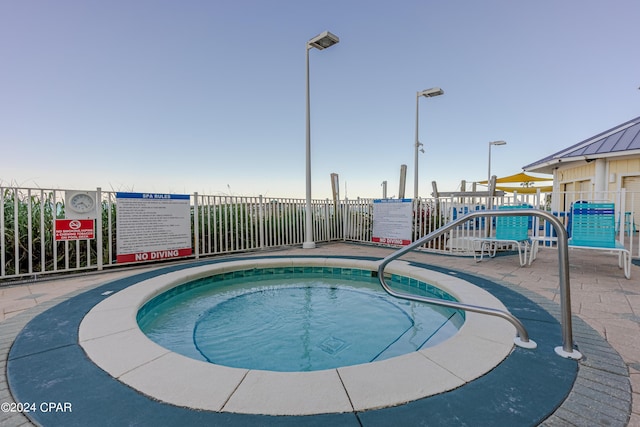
[569,202,631,279]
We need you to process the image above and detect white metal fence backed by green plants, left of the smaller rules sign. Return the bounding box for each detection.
[0,187,343,280]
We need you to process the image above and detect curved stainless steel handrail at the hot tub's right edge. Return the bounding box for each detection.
[378,209,582,359]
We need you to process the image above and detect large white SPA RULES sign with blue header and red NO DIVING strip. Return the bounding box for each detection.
[116,193,191,262]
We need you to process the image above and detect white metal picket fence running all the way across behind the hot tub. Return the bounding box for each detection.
[0,187,640,281]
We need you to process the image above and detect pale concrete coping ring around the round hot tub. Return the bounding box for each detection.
[79,257,516,415]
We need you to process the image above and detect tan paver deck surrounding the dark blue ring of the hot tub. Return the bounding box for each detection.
[0,243,640,427]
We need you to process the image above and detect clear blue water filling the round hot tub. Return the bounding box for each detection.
[138,269,464,371]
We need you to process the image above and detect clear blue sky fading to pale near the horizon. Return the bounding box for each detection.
[0,0,640,199]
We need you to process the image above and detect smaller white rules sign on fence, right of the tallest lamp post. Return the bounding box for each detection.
[371,199,413,245]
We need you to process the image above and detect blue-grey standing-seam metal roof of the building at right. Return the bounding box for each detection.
[522,117,640,173]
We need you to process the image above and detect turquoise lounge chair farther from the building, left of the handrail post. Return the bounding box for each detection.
[473,205,537,267]
